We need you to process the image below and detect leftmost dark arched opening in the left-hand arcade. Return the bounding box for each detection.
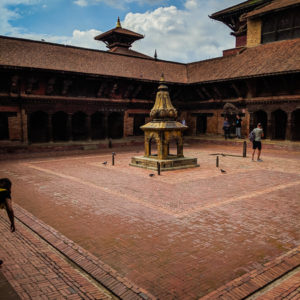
[29,111,49,143]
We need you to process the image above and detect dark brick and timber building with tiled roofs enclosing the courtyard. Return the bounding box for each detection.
[0,0,300,144]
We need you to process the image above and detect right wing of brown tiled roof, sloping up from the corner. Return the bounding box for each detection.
[187,39,300,83]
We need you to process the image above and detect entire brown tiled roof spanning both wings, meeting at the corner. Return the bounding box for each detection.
[0,37,300,83]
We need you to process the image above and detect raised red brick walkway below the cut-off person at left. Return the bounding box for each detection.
[0,214,112,299]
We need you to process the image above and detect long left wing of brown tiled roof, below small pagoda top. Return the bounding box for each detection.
[0,37,187,82]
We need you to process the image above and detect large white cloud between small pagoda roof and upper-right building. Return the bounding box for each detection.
[122,0,240,62]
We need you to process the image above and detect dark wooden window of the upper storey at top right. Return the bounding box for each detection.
[262,7,300,43]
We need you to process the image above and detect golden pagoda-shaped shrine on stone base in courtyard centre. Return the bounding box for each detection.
[130,75,199,171]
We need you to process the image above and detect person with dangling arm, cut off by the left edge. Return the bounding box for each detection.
[0,178,16,266]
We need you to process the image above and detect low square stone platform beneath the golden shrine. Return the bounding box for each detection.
[129,156,200,171]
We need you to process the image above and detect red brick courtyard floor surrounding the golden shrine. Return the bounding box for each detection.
[0,145,300,299]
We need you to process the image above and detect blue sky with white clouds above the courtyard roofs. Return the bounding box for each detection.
[0,0,242,63]
